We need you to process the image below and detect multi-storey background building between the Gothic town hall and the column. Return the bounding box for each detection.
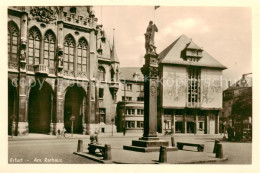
[115,67,144,133]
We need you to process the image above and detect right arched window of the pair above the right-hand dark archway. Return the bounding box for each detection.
[78,38,88,72]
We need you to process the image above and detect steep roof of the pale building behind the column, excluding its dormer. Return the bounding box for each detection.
[158,35,226,69]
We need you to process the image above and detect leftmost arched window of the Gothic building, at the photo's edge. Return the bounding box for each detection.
[8,21,19,62]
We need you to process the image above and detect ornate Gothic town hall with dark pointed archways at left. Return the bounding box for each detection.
[8,6,119,135]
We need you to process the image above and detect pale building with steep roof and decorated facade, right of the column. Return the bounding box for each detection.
[157,35,226,134]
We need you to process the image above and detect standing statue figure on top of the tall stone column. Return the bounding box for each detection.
[144,21,158,54]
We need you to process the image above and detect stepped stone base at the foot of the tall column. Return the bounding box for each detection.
[123,137,178,152]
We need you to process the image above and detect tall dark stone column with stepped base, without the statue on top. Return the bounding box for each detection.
[123,54,178,152]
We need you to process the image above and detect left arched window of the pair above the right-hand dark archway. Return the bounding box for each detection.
[63,35,75,71]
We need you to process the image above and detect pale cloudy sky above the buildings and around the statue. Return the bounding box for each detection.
[94,6,252,83]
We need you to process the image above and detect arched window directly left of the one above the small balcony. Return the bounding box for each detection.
[28,27,42,65]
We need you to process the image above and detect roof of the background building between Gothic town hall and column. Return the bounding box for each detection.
[119,67,144,82]
